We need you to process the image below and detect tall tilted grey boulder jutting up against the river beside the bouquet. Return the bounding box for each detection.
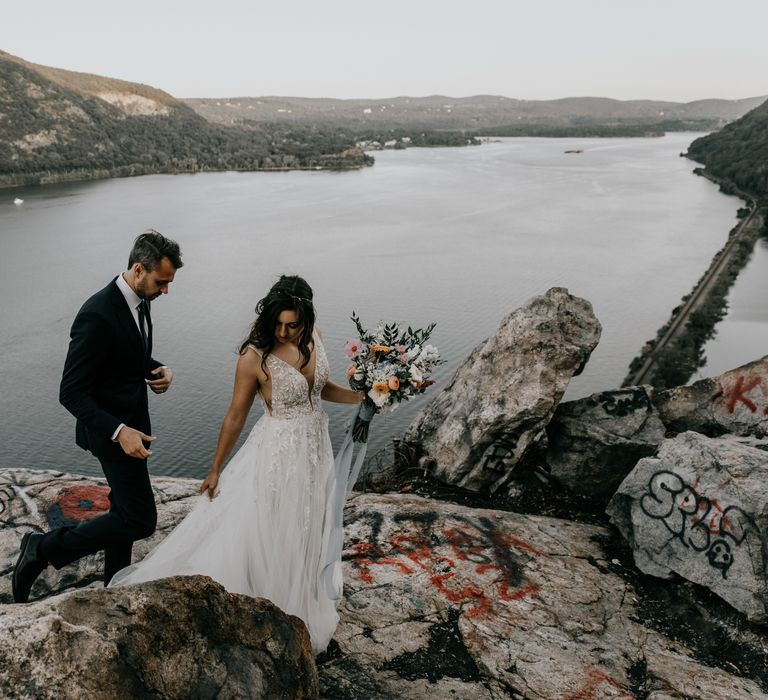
[405,287,601,491]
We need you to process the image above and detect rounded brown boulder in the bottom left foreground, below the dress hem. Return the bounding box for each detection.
[0,576,318,700]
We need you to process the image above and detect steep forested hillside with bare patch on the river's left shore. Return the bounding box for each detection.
[0,53,372,186]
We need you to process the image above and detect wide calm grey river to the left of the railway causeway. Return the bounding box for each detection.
[0,133,748,476]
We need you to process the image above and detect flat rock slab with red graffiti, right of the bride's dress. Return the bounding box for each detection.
[319,494,768,700]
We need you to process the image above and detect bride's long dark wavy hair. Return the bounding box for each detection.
[240,275,315,369]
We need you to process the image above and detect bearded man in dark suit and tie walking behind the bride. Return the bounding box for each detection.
[12,229,182,603]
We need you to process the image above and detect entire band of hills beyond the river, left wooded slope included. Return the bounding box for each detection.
[0,51,765,187]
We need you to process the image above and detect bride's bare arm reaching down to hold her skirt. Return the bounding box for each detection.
[199,350,266,499]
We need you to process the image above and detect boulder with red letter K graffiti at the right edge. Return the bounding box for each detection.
[654,355,768,437]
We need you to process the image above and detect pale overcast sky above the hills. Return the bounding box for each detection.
[0,0,768,101]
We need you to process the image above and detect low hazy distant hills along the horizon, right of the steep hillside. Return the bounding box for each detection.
[184,95,766,135]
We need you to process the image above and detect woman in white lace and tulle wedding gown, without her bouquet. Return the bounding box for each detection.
[110,276,364,653]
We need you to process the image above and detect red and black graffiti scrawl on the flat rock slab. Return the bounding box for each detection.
[344,511,541,617]
